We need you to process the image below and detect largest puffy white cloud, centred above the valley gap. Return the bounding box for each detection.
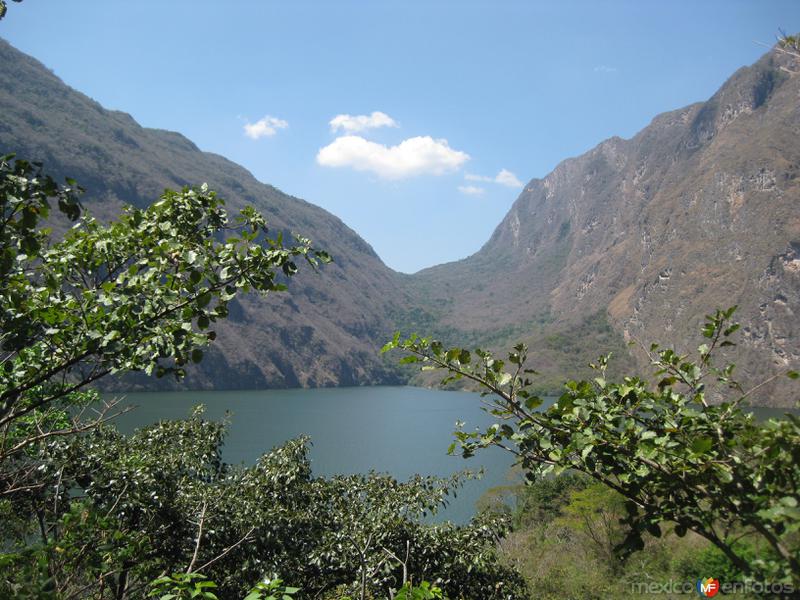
[317,135,469,179]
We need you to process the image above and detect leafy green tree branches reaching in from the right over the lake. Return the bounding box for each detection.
[384,307,800,585]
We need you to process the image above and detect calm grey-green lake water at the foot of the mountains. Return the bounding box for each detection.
[109,386,512,522]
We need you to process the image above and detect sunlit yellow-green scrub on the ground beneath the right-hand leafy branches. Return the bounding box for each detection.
[487,473,768,600]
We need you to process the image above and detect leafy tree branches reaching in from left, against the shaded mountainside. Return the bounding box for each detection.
[0,156,330,497]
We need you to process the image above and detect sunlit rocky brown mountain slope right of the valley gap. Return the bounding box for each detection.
[411,53,800,405]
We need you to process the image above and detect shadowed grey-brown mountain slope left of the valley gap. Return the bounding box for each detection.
[0,40,404,388]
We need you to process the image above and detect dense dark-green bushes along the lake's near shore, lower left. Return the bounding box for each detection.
[0,411,525,599]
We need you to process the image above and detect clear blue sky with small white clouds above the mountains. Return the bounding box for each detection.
[0,0,800,272]
